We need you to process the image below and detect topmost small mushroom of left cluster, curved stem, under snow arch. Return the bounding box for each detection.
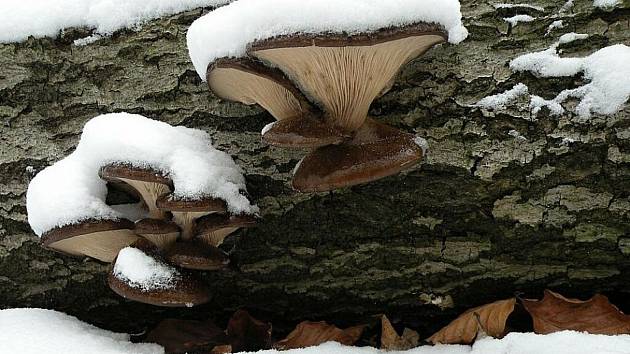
[99,164,172,219]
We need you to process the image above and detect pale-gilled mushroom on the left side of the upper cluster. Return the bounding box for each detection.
[206,58,310,120]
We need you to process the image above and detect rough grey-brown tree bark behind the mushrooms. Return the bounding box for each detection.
[0,0,630,334]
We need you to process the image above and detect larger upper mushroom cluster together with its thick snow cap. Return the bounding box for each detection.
[187,0,467,192]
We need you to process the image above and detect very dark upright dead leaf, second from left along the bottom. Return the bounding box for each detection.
[226,310,271,352]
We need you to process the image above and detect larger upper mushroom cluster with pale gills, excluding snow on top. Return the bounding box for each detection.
[200,23,448,192]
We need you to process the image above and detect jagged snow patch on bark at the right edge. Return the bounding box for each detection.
[510,44,630,118]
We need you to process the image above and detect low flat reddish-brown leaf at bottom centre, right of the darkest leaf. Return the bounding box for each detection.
[274,321,365,350]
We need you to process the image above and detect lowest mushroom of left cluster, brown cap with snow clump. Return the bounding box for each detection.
[107,239,210,307]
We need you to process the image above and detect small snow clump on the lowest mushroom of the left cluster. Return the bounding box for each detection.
[113,247,181,291]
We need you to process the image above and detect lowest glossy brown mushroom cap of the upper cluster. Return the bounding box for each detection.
[293,120,423,192]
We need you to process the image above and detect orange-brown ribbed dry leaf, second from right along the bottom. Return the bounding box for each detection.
[427,298,516,344]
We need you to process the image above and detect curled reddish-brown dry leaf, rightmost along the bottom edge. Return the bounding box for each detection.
[521,290,630,335]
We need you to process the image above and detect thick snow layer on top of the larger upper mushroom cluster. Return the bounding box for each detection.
[187,0,468,81]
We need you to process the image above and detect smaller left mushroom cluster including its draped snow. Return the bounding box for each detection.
[27,114,257,306]
